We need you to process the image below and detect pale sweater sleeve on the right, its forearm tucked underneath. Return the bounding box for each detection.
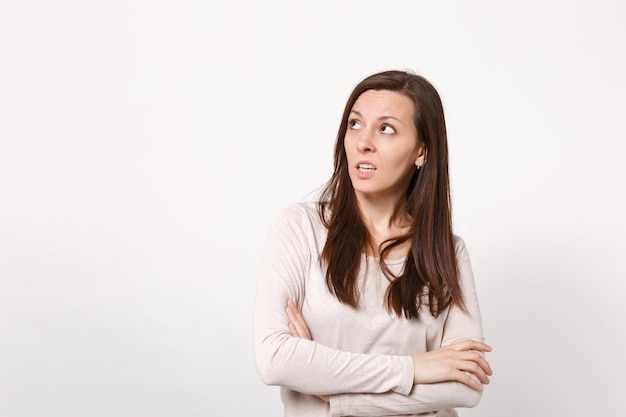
[330,238,484,416]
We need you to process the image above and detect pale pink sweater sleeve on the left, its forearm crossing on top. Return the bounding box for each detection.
[254,207,413,395]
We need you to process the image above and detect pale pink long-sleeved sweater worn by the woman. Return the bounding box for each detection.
[254,202,483,417]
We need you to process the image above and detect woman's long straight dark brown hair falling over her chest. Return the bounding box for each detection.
[318,71,465,318]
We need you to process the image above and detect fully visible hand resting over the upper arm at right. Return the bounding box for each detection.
[412,340,492,391]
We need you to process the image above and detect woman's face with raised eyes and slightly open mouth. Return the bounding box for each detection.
[344,90,424,201]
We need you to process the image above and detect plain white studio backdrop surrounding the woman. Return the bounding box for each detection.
[0,0,626,417]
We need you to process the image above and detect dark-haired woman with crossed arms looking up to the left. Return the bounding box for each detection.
[254,71,491,417]
